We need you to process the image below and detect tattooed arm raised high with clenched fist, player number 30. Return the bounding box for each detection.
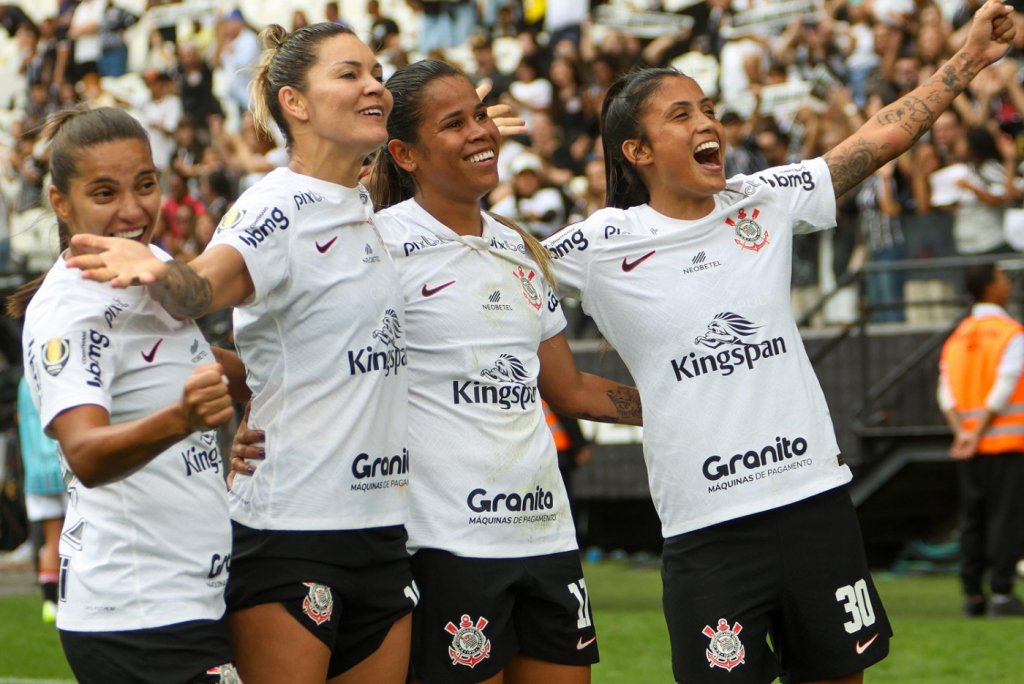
[822,0,1015,197]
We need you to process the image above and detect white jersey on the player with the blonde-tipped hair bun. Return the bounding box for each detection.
[210,168,410,530]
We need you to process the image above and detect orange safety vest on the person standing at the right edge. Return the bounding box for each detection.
[942,315,1024,454]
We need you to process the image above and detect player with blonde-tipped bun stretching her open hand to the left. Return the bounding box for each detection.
[70,23,417,684]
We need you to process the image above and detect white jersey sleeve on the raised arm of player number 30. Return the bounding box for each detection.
[751,157,836,233]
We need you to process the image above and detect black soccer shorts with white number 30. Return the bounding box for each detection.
[662,486,892,684]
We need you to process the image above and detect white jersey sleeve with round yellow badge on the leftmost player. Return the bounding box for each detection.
[25,316,117,436]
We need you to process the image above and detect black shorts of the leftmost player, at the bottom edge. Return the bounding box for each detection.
[60,618,235,684]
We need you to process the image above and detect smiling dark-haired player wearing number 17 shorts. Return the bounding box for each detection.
[233,60,640,684]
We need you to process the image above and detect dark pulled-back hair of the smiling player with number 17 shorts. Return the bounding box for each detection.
[367,59,554,283]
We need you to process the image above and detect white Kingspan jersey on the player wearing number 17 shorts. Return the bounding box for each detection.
[377,200,577,558]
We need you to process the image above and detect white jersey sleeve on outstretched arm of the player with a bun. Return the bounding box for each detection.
[203,194,295,308]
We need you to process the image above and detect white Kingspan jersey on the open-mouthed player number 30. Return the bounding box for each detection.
[545,159,851,537]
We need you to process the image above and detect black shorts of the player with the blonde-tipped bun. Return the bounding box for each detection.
[225,522,418,678]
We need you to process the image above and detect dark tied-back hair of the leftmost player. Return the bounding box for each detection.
[6,105,153,318]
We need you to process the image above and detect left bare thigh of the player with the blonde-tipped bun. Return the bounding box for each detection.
[227,603,331,684]
